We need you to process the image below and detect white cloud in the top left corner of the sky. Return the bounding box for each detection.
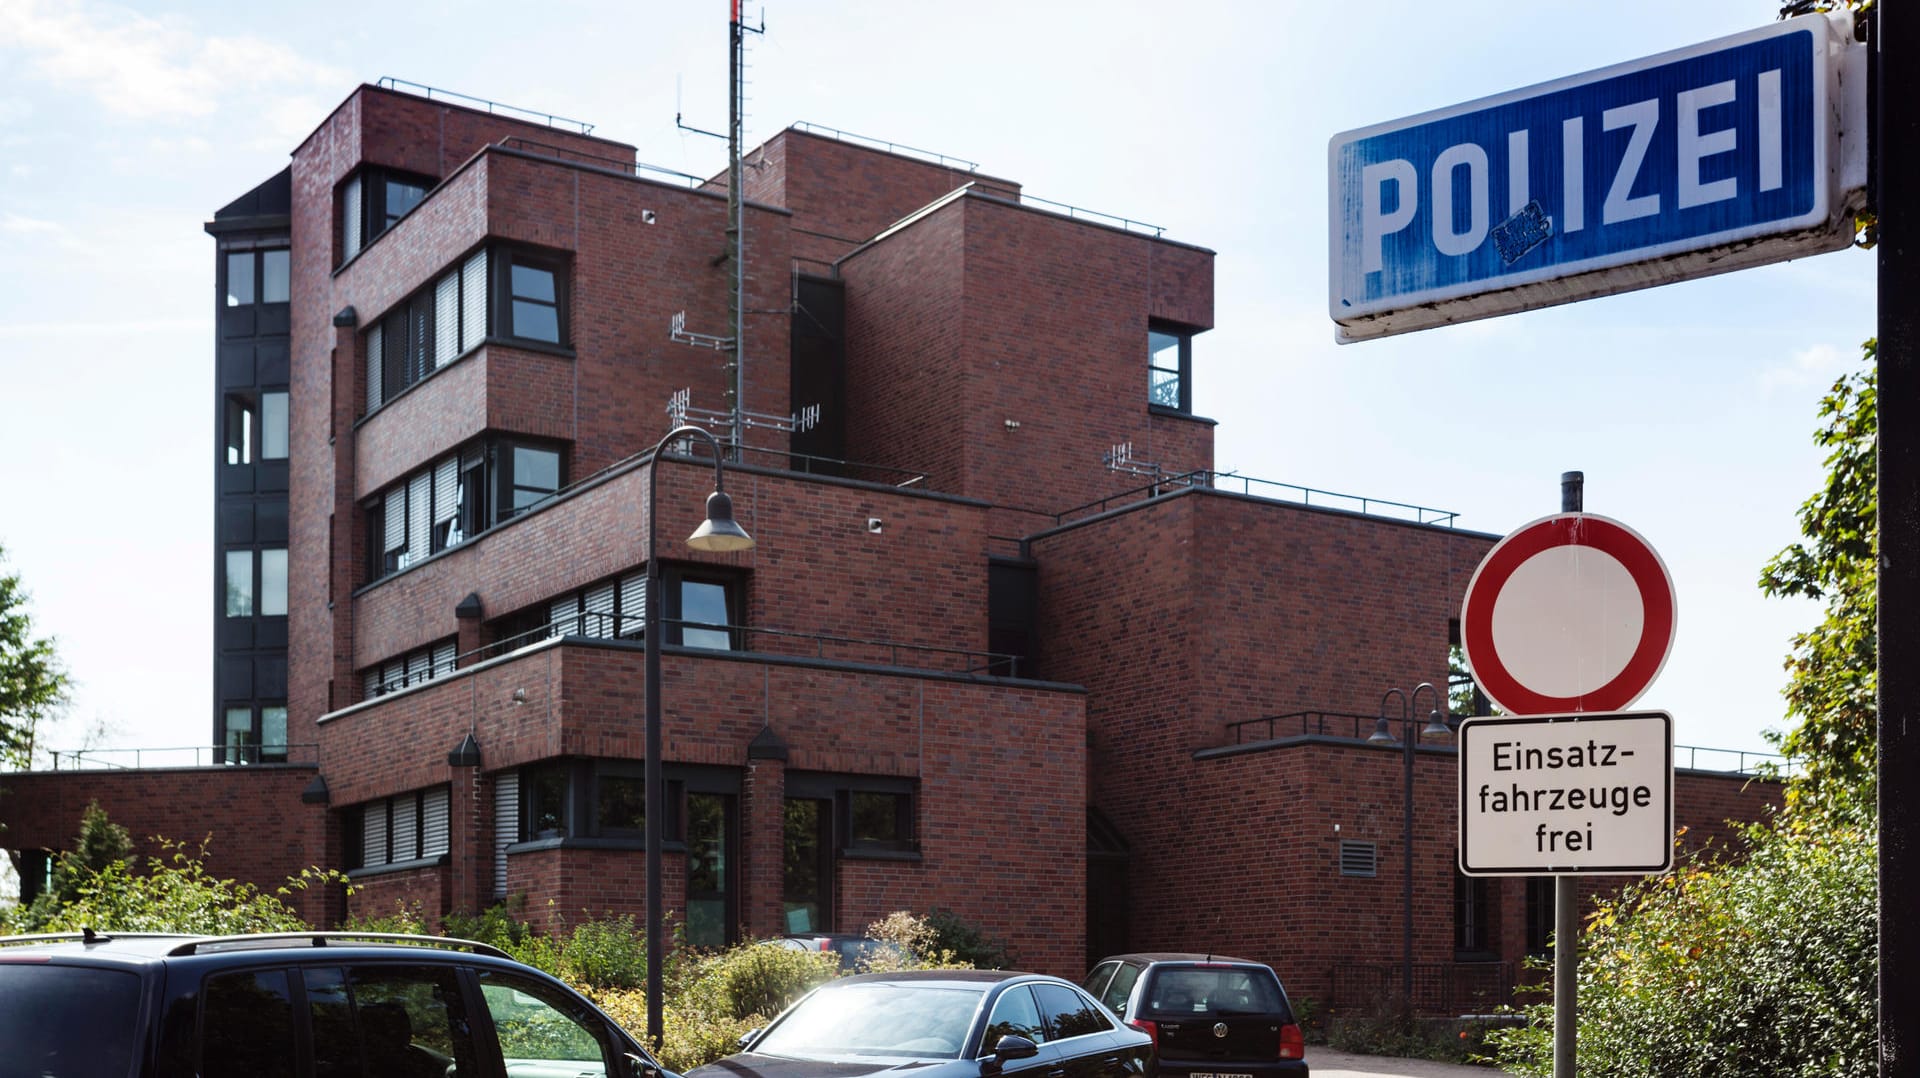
[0,0,348,119]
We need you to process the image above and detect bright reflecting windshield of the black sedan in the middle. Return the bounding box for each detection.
[753,982,981,1059]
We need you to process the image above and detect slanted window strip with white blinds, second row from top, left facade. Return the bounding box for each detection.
[363,248,488,413]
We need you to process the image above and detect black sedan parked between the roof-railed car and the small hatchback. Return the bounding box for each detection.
[687,970,1154,1078]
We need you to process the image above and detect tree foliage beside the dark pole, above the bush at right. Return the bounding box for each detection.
[1761,340,1880,813]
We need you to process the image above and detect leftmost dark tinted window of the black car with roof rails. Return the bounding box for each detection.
[0,963,140,1074]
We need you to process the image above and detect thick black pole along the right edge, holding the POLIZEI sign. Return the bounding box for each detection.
[1868,2,1920,1076]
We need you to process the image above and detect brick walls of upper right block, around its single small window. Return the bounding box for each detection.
[839,196,1213,528]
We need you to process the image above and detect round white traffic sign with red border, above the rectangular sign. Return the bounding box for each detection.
[1459,513,1674,715]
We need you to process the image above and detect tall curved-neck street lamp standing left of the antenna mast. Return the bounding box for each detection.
[645,425,753,1051]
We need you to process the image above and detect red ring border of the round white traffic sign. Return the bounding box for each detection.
[1459,513,1674,715]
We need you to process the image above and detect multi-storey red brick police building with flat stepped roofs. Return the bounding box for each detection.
[0,86,1772,1009]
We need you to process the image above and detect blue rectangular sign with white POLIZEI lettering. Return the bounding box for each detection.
[1329,15,1864,340]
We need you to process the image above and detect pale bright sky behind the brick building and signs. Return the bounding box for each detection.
[0,0,1874,763]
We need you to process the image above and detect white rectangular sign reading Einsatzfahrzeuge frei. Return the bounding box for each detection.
[1459,711,1674,876]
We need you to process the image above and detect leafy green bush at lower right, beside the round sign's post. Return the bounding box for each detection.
[1488,813,1878,1078]
